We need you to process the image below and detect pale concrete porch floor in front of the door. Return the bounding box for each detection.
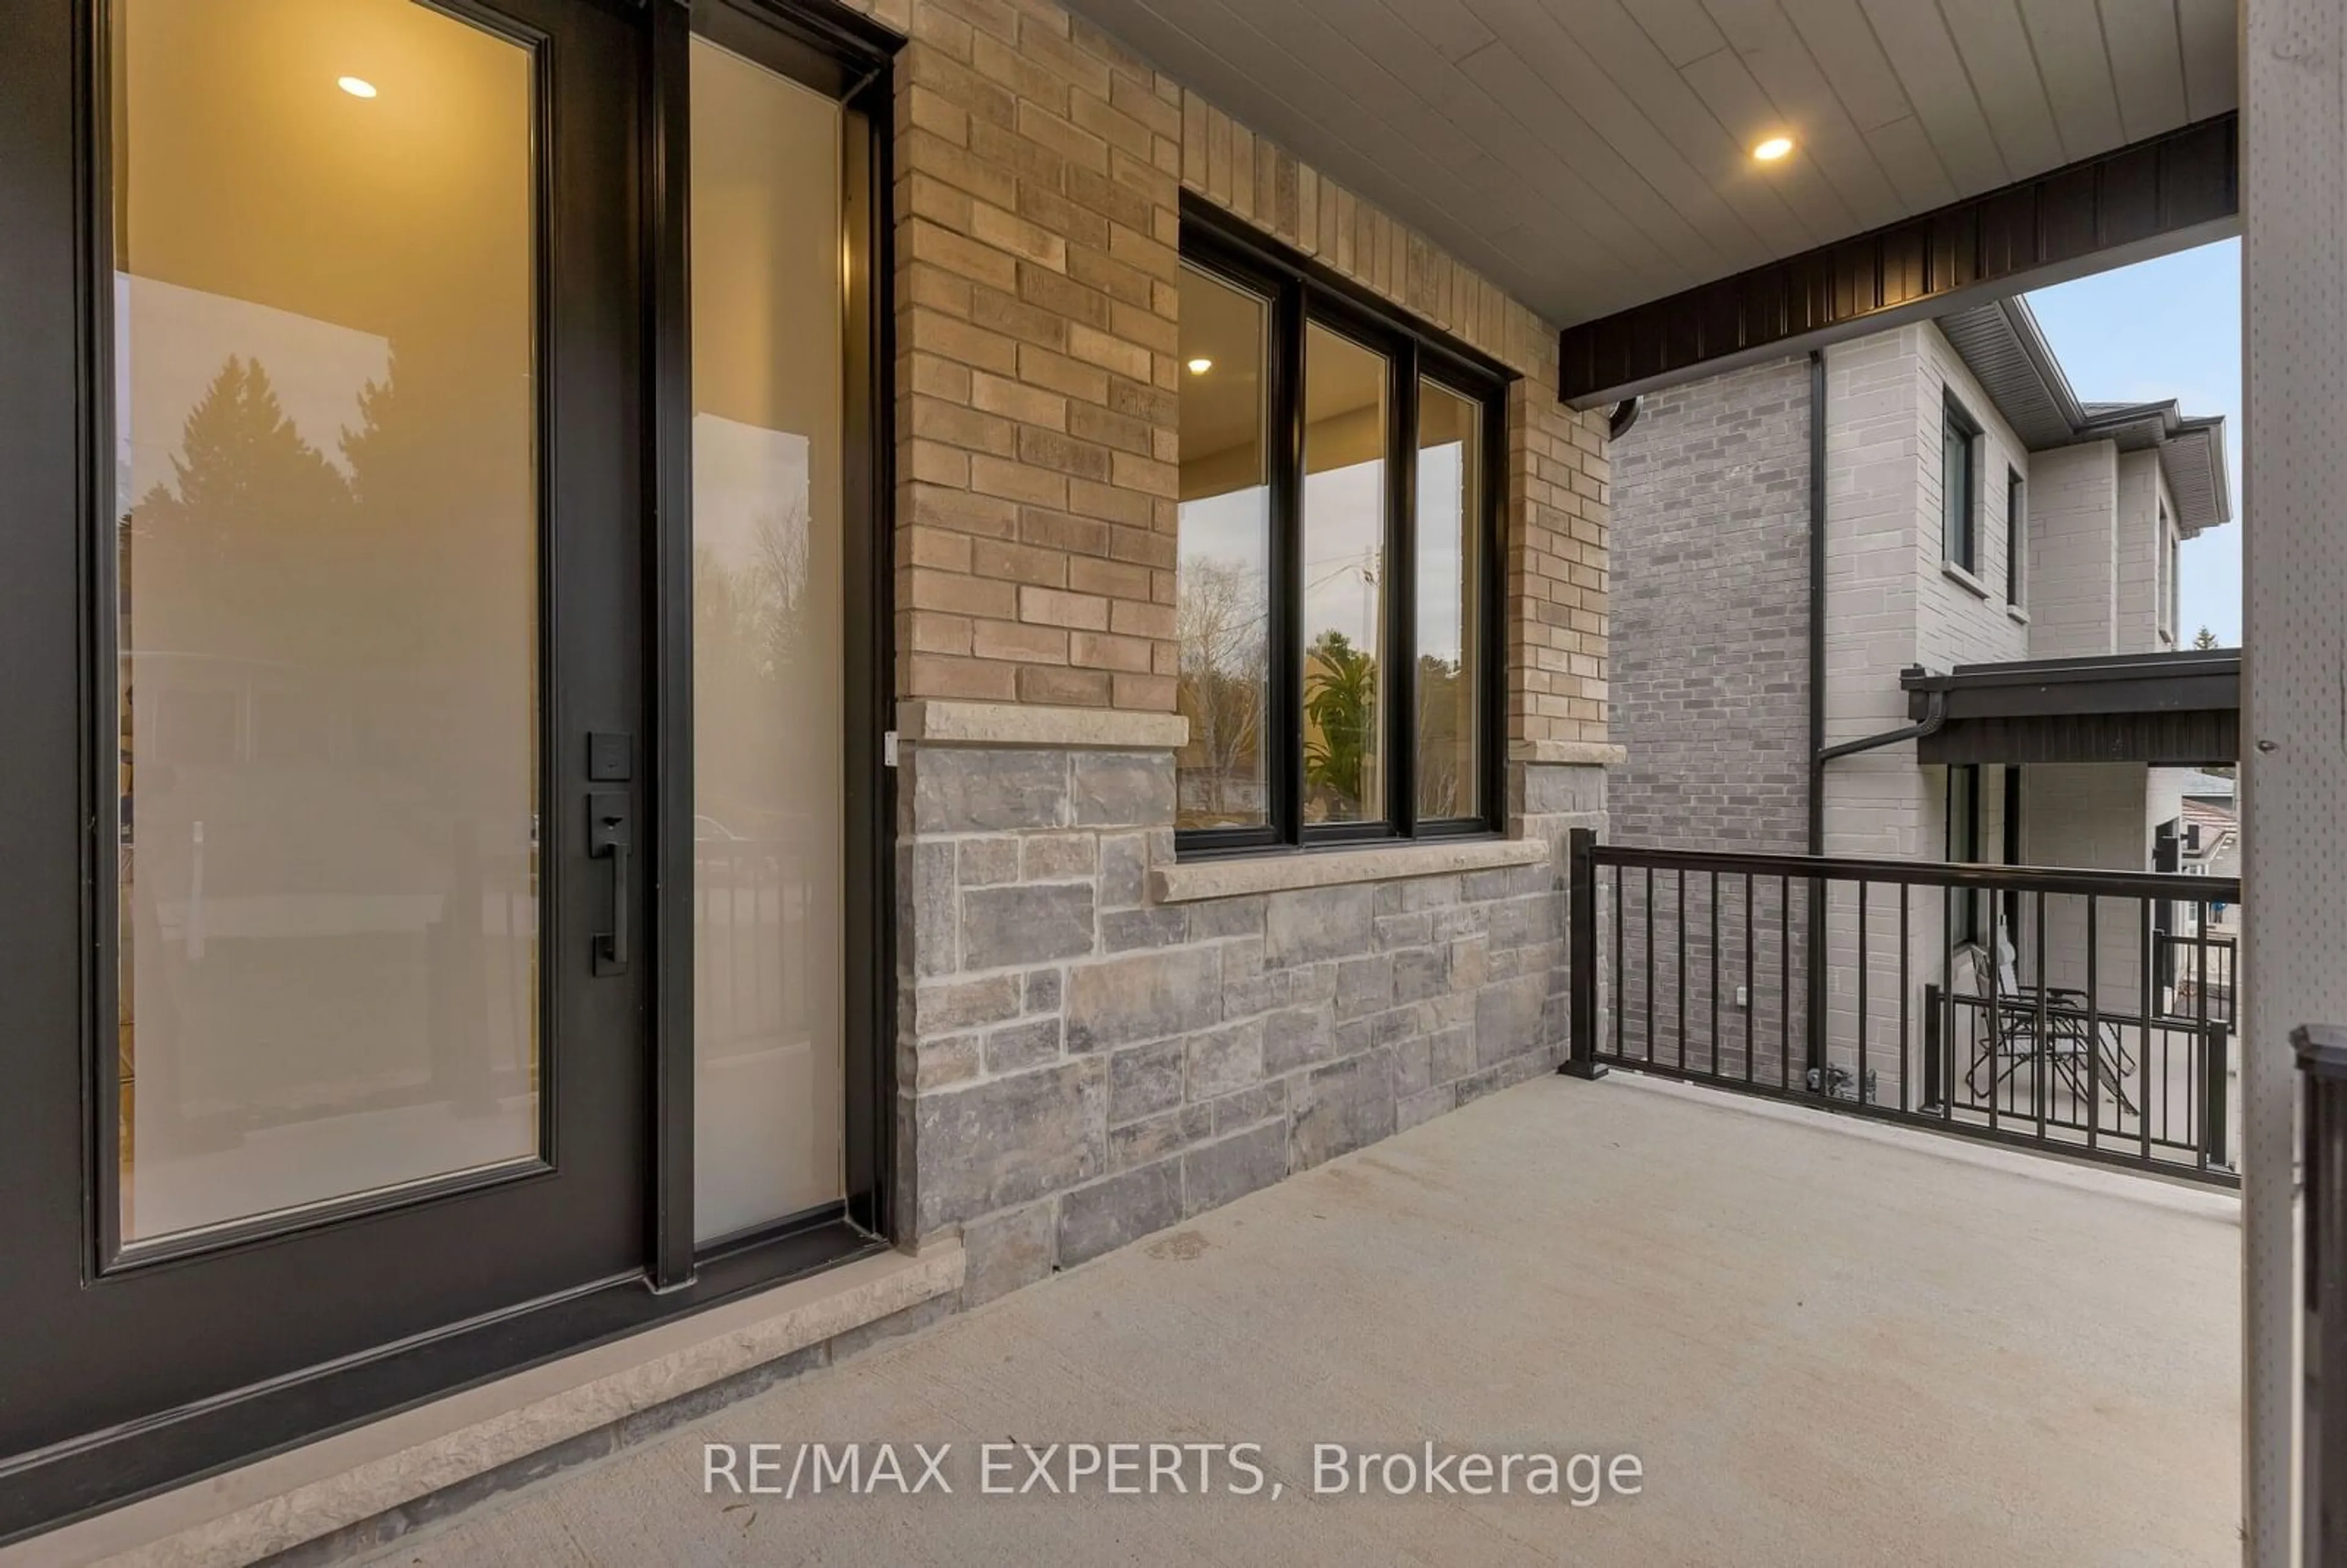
[361,1072,2241,1568]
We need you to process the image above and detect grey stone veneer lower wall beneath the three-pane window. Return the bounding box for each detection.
[897,744,1603,1300]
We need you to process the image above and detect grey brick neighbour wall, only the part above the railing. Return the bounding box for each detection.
[1607,359,1810,854]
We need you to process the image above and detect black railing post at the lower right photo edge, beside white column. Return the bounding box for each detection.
[2291,1024,2347,1563]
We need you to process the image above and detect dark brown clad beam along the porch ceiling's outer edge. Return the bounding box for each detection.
[1559,112,2241,408]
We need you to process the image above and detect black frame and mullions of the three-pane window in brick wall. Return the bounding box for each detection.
[1174,197,1514,859]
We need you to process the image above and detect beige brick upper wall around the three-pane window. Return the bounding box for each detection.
[869,0,1607,742]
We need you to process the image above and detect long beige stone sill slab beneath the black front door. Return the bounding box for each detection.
[0,1239,962,1568]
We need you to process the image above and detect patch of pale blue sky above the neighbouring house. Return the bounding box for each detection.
[2028,240,2241,648]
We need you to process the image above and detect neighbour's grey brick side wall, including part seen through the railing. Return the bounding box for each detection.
[1601,359,1810,1082]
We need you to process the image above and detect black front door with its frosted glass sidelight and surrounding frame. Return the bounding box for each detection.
[0,0,894,1542]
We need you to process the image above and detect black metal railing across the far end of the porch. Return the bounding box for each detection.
[1570,831,2241,1183]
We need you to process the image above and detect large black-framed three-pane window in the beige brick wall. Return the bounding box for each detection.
[1176,207,1509,854]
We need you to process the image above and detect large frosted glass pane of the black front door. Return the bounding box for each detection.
[108,0,537,1242]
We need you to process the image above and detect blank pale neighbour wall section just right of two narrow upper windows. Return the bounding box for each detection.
[2028,441,2120,659]
